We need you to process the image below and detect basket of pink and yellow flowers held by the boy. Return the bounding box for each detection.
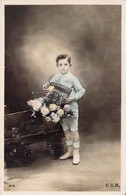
[27,83,74,123]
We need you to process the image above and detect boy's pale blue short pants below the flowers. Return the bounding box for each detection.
[61,117,78,131]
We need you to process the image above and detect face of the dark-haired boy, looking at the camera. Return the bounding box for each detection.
[57,59,70,74]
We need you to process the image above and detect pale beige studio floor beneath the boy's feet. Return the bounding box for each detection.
[5,133,120,191]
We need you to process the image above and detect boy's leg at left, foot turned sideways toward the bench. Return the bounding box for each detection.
[59,130,73,160]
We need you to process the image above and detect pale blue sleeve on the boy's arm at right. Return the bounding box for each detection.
[73,77,85,100]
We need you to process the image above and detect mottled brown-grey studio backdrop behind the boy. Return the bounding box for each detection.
[5,5,121,139]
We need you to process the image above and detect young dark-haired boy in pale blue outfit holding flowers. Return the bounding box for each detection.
[43,54,85,165]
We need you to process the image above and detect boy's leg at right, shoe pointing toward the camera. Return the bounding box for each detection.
[72,130,80,165]
